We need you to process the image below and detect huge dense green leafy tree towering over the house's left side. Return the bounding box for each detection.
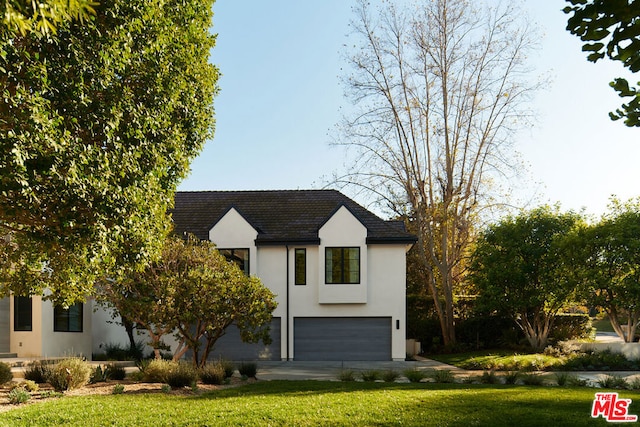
[0,0,218,303]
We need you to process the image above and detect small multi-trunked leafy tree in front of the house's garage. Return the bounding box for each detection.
[99,237,277,365]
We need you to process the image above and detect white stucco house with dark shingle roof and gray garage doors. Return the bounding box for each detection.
[0,190,416,360]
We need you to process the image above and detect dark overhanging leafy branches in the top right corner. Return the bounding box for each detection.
[564,0,640,126]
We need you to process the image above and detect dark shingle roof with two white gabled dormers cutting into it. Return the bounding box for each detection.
[171,190,416,245]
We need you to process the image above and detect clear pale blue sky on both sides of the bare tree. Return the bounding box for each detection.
[179,0,640,219]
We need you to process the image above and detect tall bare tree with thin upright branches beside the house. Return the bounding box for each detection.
[338,0,539,345]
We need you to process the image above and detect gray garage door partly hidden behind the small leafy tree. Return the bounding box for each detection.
[209,317,281,361]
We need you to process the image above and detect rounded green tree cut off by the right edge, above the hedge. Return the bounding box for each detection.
[576,199,640,342]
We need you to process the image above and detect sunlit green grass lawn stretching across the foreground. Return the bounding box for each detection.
[0,381,640,427]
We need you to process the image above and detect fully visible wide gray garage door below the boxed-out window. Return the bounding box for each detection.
[293,317,391,360]
